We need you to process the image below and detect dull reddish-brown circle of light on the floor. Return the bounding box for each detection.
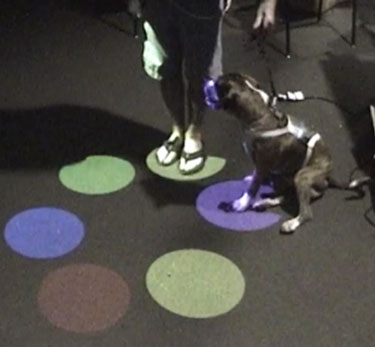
[38,264,130,333]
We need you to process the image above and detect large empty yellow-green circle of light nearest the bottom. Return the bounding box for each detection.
[146,249,245,318]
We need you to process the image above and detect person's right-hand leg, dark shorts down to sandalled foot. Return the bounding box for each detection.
[179,10,222,174]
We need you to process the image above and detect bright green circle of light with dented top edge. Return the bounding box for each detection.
[59,155,135,195]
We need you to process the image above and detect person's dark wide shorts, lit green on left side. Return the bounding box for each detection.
[143,0,223,82]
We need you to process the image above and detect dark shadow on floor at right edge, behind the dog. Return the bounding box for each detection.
[321,52,375,226]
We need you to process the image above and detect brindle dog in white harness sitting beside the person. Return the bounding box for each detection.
[205,73,370,233]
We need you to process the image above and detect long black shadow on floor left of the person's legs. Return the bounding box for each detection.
[0,105,165,170]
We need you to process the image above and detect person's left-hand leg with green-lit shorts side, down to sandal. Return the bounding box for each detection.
[144,0,185,165]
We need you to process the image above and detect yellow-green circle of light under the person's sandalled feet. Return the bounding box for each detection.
[146,148,226,181]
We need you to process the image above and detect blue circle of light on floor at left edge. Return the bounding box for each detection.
[5,207,85,259]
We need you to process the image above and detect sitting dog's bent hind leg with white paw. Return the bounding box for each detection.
[281,166,327,234]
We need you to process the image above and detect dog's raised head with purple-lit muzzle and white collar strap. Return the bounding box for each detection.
[204,73,269,121]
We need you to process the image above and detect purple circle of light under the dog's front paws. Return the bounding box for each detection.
[196,181,281,231]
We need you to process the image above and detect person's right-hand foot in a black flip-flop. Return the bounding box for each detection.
[178,138,206,175]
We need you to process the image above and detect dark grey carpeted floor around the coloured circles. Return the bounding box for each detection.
[0,1,375,347]
